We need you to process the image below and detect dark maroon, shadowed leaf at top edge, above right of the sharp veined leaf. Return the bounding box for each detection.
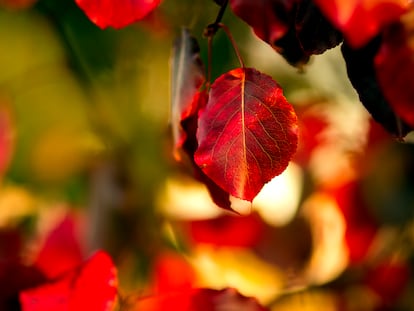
[230,0,342,67]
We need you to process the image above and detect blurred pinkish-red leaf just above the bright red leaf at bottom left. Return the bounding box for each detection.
[35,215,83,279]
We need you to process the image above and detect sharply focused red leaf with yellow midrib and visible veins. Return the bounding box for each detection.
[194,68,297,201]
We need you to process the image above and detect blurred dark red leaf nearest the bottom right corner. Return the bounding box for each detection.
[364,261,410,307]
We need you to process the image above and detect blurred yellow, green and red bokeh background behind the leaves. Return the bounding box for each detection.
[0,0,414,310]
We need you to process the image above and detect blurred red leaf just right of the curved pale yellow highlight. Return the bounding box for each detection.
[331,181,378,264]
